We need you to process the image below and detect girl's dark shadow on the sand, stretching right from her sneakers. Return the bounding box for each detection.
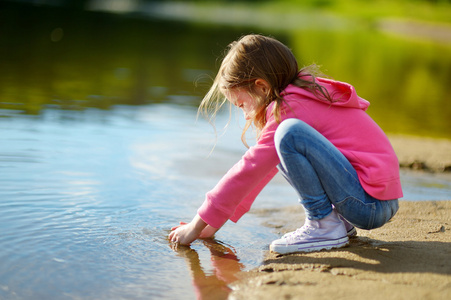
[259,237,451,275]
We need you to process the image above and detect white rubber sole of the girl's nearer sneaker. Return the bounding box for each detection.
[269,236,349,254]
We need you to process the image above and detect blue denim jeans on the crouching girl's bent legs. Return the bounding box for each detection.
[274,119,398,229]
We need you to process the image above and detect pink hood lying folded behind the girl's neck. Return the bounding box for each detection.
[281,77,370,110]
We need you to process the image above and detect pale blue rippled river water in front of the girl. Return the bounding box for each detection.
[0,104,451,299]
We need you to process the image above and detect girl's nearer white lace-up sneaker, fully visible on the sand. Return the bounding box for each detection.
[269,211,349,254]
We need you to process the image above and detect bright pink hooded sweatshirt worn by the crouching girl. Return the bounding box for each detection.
[198,78,402,228]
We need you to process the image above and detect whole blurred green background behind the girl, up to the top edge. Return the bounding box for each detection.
[0,0,451,138]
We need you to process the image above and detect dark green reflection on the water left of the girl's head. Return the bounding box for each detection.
[0,3,247,115]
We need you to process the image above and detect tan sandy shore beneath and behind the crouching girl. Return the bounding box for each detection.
[229,136,451,300]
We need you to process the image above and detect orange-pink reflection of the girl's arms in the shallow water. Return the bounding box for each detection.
[170,239,244,300]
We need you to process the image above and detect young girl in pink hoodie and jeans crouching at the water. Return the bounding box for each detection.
[169,35,402,254]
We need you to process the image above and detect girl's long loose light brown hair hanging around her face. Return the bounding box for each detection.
[198,34,332,146]
